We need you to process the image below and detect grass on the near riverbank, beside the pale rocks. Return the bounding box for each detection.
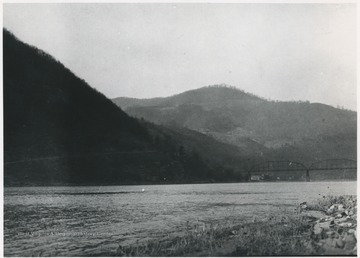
[107,196,356,257]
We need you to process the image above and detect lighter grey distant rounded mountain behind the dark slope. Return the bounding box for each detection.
[113,85,356,163]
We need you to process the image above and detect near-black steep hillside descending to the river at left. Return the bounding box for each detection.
[3,30,242,185]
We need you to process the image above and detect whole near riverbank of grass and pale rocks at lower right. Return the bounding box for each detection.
[112,196,357,256]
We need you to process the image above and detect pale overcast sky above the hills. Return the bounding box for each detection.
[3,3,356,110]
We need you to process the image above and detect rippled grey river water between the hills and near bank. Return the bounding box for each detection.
[4,181,356,256]
